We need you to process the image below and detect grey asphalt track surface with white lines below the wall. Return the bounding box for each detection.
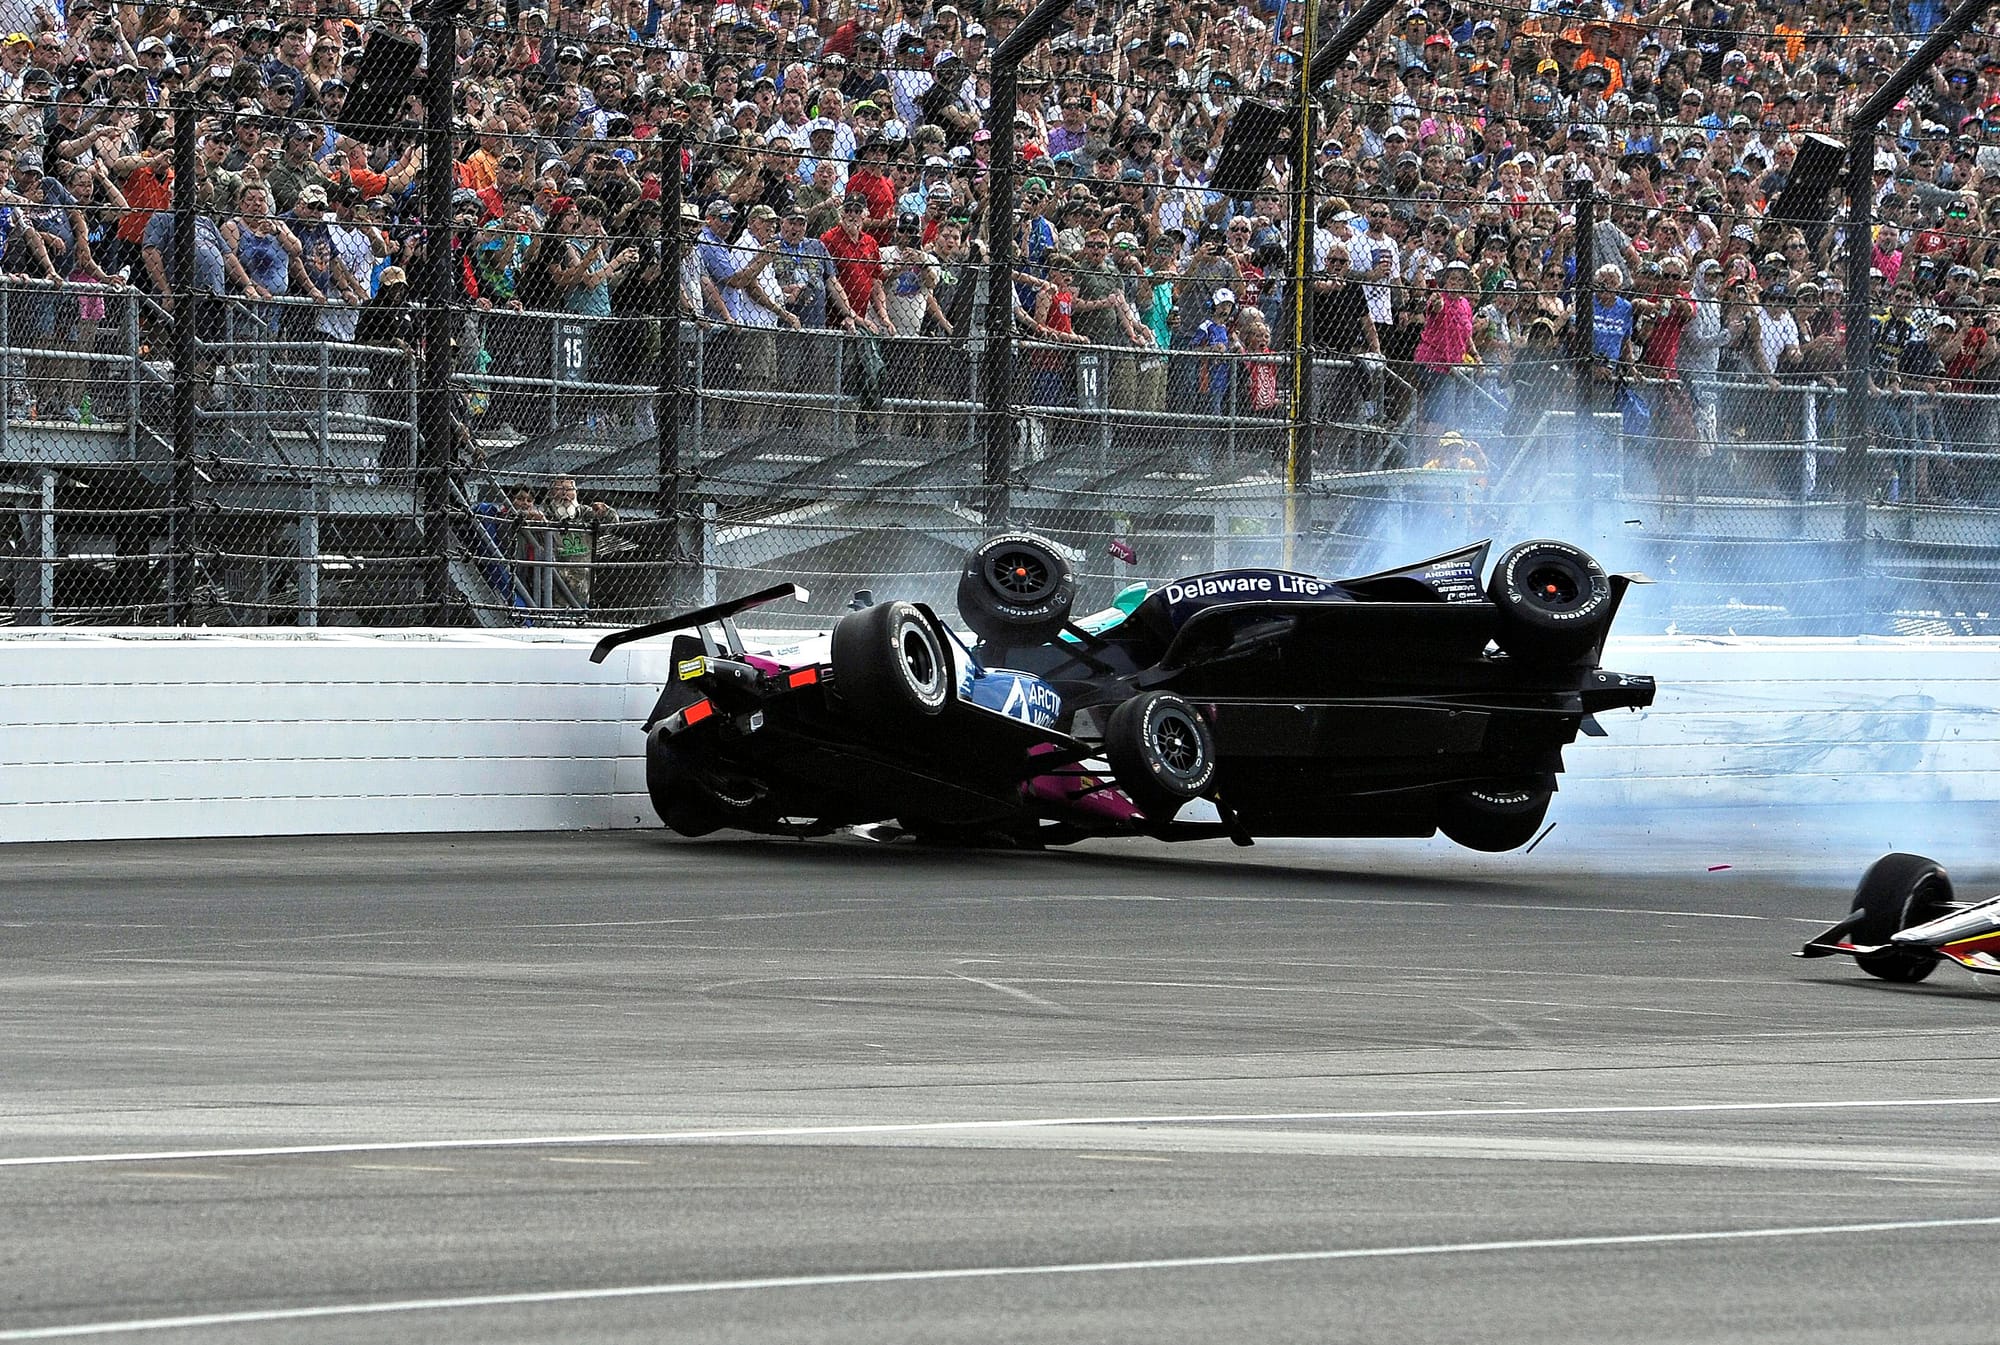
[0,829,2000,1345]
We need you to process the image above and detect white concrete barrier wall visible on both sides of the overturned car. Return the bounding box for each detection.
[0,628,2000,841]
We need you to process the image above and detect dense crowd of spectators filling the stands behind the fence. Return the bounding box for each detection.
[0,0,2000,498]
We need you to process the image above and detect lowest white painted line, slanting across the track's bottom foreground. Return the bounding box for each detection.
[0,1215,2000,1341]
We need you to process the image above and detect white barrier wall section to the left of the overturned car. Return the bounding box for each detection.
[0,628,666,841]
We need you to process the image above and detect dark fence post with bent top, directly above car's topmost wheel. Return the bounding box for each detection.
[980,0,1070,530]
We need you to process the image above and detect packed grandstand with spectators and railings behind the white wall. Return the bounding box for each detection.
[0,0,2000,634]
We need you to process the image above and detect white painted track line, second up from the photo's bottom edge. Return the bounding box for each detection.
[0,1097,2000,1167]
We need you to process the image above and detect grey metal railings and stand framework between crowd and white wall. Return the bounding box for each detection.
[0,280,2000,628]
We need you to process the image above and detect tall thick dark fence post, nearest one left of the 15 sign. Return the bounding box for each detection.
[416,0,458,626]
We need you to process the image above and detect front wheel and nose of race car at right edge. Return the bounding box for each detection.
[1794,855,2000,983]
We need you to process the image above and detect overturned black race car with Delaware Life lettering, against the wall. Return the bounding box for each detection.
[592,532,1654,851]
